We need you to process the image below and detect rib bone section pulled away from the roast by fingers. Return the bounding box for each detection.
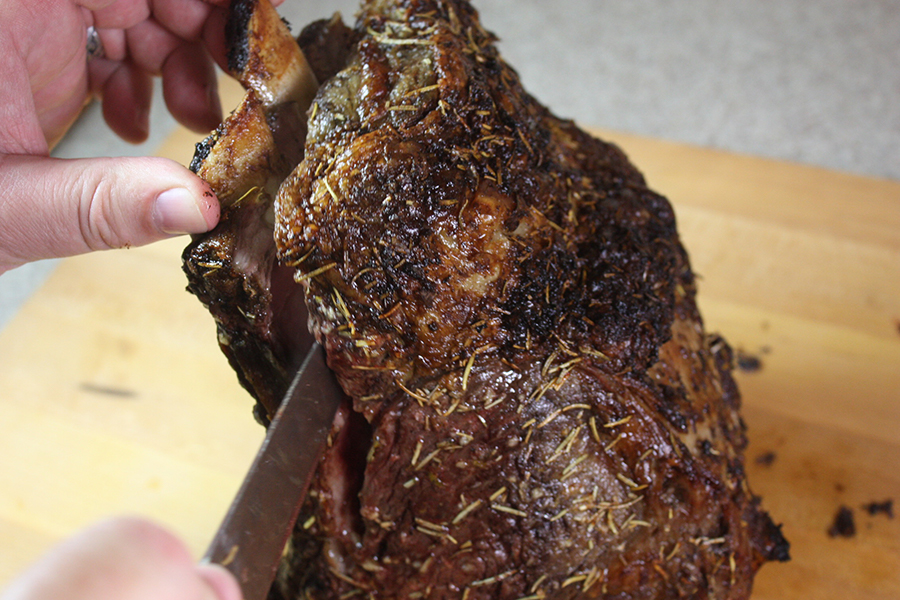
[183,0,322,423]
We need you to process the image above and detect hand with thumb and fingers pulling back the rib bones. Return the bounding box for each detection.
[0,0,279,273]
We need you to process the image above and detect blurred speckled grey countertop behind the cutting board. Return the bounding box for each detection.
[0,0,900,328]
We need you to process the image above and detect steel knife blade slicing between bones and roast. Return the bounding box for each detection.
[203,343,344,600]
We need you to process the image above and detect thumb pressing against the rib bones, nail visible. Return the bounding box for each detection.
[0,155,219,273]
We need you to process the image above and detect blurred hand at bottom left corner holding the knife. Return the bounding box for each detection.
[0,518,241,600]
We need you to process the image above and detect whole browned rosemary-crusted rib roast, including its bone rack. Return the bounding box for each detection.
[184,0,788,600]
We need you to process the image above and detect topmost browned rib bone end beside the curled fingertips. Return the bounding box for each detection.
[225,0,318,112]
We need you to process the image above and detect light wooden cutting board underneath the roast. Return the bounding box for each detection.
[0,78,900,600]
